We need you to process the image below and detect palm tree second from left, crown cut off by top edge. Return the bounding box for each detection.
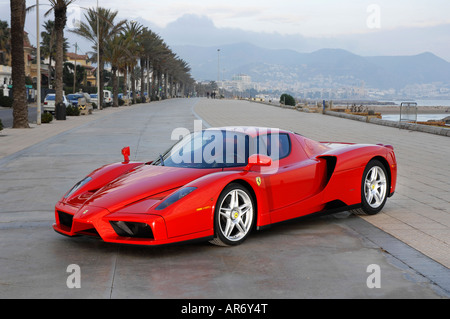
[44,0,76,109]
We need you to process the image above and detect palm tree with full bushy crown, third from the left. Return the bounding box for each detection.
[70,7,126,109]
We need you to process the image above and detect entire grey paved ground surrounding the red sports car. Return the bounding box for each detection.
[0,99,450,298]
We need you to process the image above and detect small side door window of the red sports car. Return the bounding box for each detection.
[257,133,291,161]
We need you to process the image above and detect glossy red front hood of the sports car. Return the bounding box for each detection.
[76,165,217,212]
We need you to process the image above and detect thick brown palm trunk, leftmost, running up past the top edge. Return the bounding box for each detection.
[10,0,30,128]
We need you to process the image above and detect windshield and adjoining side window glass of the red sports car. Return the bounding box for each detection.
[152,130,290,168]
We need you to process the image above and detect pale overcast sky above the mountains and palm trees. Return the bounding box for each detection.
[0,0,450,60]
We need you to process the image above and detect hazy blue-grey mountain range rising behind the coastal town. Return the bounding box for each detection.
[173,43,450,89]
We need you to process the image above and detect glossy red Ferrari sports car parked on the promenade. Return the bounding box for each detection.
[53,127,397,245]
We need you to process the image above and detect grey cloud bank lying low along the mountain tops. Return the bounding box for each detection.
[149,15,450,61]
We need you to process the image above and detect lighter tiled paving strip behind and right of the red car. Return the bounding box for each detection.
[195,100,450,268]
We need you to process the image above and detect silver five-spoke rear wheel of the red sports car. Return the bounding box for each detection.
[352,160,389,215]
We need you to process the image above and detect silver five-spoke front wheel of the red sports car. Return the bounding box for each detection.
[210,183,255,246]
